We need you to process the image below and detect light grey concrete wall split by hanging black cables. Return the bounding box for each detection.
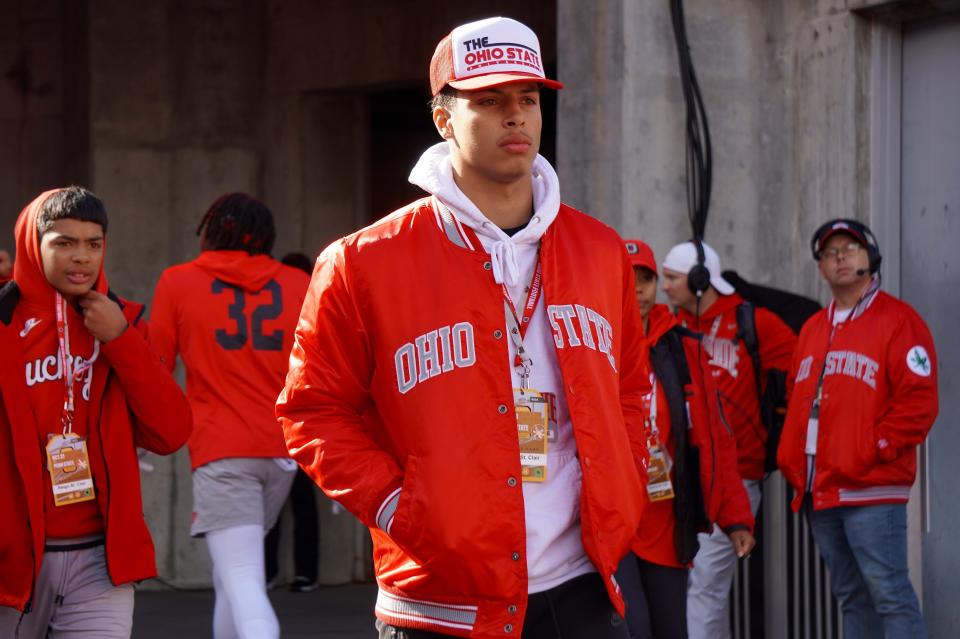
[557,0,884,296]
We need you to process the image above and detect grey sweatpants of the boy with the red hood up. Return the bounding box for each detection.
[0,546,133,639]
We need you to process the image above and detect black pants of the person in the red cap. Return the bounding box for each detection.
[617,552,689,639]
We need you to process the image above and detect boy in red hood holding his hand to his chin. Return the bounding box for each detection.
[0,186,192,639]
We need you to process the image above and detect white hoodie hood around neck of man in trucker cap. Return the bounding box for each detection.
[409,142,560,286]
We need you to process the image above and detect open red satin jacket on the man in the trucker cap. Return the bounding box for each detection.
[277,200,649,637]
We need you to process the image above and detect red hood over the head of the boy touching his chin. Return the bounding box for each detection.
[13,189,107,314]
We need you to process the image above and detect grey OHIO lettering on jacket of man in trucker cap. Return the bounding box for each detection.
[393,322,477,395]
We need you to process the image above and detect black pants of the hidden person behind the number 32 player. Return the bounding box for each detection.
[263,468,320,582]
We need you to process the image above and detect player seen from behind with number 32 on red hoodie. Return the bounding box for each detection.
[150,193,309,639]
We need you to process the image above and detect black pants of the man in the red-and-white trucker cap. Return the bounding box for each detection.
[377,572,629,639]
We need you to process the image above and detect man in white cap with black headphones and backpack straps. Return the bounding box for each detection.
[662,242,797,639]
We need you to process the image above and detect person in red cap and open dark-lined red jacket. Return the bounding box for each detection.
[617,240,755,639]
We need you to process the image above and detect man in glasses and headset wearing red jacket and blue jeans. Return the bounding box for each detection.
[777,219,937,639]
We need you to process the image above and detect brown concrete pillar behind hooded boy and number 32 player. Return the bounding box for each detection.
[89,0,264,587]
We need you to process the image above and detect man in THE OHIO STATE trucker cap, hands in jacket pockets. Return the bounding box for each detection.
[277,18,649,639]
